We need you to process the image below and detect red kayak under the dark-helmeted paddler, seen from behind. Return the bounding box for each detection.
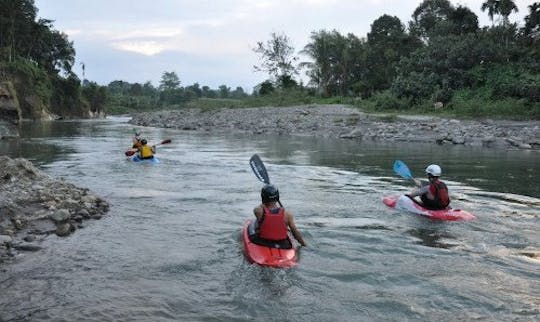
[242,219,298,268]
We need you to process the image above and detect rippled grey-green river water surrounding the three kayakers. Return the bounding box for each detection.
[0,118,540,321]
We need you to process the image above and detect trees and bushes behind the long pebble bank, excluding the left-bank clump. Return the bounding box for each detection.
[107,0,540,119]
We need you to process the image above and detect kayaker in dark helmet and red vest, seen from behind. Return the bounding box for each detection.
[253,184,307,246]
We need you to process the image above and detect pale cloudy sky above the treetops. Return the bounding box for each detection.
[35,0,533,92]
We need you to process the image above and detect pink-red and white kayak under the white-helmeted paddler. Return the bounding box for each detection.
[383,195,476,220]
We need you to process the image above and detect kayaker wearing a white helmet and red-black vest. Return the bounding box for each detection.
[408,164,450,210]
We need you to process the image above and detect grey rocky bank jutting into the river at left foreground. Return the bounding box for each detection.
[0,156,109,264]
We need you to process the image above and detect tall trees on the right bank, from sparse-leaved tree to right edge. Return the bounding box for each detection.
[254,0,540,117]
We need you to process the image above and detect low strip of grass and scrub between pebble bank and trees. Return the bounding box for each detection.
[103,90,540,123]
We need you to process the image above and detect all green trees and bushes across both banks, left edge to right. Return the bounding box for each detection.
[0,0,540,119]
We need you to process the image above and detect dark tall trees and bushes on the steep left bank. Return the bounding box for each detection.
[0,0,107,119]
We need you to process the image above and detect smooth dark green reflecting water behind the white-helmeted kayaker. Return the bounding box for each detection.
[249,136,540,198]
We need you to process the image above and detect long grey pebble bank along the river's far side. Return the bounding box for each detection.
[130,105,540,150]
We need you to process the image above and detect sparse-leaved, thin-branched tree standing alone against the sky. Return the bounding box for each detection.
[253,33,298,86]
